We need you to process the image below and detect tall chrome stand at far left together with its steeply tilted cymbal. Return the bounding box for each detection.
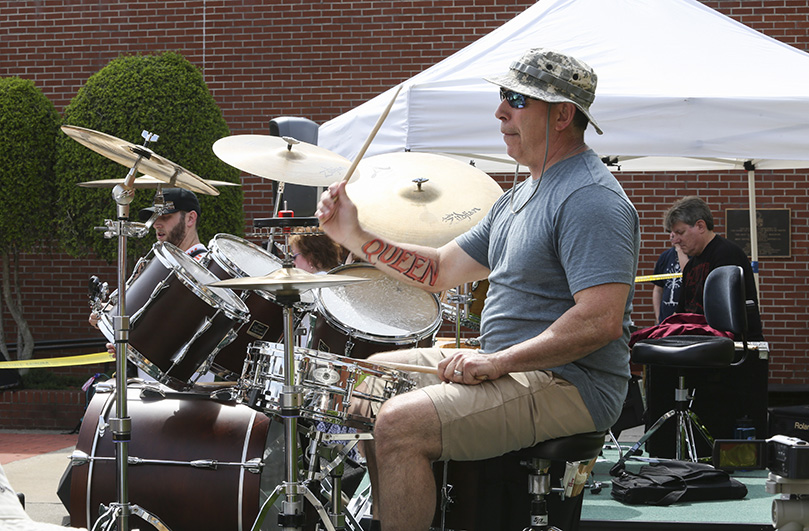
[61,125,219,531]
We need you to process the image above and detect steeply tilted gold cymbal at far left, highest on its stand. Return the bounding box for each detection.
[62,125,219,195]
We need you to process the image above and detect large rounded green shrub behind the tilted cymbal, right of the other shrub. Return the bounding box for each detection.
[56,52,244,262]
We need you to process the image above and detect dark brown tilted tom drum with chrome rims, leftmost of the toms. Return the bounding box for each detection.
[98,242,249,390]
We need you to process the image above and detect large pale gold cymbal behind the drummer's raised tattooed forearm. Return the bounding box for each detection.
[346,152,503,247]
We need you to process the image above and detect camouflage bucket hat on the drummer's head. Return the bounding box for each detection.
[484,48,603,135]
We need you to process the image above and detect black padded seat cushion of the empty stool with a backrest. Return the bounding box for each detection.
[632,336,736,369]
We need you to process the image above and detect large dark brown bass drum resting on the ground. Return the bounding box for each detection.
[70,386,316,531]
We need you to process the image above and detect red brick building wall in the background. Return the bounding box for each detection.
[0,0,809,385]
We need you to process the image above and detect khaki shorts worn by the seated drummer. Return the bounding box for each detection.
[368,348,595,461]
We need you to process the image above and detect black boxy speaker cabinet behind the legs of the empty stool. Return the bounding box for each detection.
[645,350,769,458]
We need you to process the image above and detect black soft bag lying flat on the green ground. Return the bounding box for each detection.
[611,461,747,505]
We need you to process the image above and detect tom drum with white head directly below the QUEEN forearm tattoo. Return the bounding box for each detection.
[309,264,441,359]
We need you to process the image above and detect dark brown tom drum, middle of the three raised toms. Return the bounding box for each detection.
[206,234,284,380]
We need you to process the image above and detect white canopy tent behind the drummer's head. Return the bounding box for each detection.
[319,0,809,284]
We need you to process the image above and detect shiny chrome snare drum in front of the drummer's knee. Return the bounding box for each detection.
[240,341,415,430]
